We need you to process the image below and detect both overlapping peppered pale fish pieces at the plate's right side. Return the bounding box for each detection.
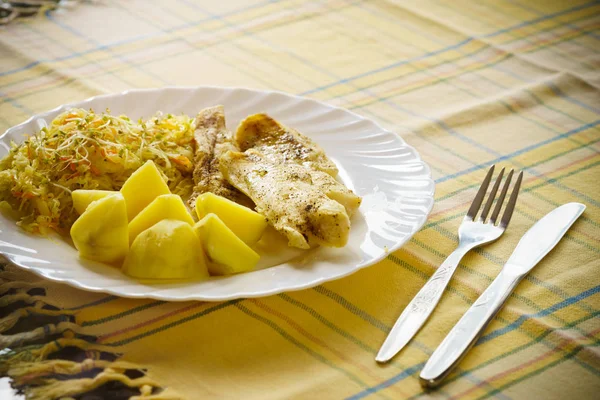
[219,114,361,249]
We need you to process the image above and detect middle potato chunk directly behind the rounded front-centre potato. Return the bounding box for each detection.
[129,194,194,243]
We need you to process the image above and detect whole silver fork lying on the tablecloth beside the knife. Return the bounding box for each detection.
[375,165,523,362]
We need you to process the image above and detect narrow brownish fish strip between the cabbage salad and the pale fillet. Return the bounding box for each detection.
[188,106,252,208]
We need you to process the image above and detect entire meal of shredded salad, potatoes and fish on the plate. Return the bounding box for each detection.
[0,106,361,279]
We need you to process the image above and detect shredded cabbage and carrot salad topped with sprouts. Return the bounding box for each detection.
[0,109,194,234]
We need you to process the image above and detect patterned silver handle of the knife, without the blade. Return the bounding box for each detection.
[420,265,523,388]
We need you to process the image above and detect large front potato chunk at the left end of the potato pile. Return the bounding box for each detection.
[71,192,129,263]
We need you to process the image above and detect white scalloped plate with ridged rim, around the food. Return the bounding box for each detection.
[0,87,434,301]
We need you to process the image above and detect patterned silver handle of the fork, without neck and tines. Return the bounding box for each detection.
[375,245,473,362]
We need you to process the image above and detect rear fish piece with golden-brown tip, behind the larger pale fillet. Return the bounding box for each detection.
[234,114,338,176]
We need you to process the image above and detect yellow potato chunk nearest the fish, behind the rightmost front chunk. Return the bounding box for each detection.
[196,193,267,246]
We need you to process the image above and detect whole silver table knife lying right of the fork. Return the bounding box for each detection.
[420,203,585,388]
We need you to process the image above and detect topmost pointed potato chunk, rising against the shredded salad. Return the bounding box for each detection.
[121,161,171,221]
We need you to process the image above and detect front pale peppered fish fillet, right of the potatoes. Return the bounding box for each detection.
[220,149,350,249]
